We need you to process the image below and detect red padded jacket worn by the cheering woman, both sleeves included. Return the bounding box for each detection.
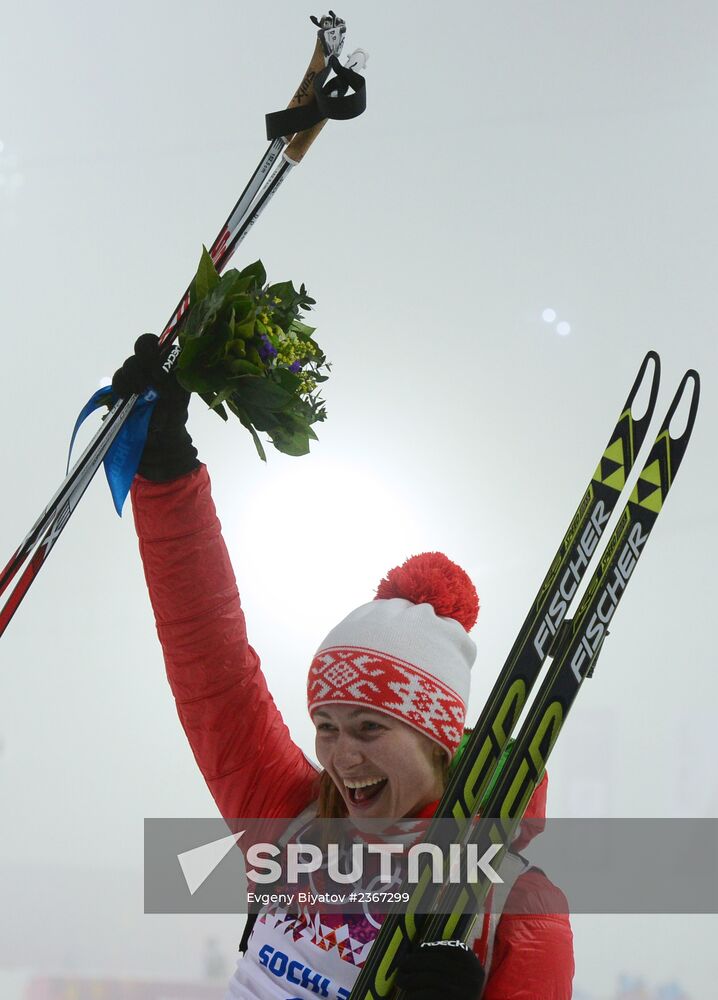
[132,466,574,1000]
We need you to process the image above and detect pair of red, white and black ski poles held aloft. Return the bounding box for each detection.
[0,11,367,636]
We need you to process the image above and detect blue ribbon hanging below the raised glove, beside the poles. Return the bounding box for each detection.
[67,385,159,517]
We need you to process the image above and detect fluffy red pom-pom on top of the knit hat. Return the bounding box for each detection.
[376,552,479,632]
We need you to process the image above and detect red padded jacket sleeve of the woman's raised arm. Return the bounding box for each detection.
[132,466,318,819]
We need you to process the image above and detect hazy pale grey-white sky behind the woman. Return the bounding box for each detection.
[0,0,718,996]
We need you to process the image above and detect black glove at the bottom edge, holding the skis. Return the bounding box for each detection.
[396,941,486,1000]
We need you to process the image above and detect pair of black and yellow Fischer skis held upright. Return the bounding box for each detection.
[350,351,700,1000]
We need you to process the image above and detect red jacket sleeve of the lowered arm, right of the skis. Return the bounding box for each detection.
[482,869,574,1000]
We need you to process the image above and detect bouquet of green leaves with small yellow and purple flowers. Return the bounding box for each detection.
[175,248,330,461]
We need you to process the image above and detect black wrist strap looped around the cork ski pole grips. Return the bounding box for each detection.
[265,56,366,141]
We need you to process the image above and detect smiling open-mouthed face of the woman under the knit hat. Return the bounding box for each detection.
[312,704,443,819]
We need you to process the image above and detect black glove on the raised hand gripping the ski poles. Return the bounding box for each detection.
[112,333,200,483]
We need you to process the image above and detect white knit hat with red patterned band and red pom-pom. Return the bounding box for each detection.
[307,552,479,755]
